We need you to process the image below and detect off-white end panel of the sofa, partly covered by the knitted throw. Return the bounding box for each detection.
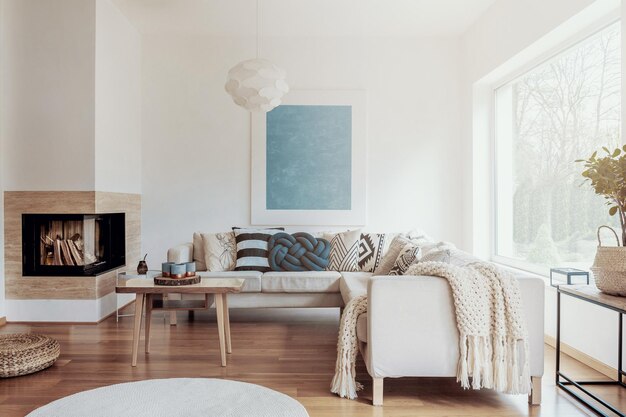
[366,276,545,378]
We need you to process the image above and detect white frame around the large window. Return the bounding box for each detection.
[489,17,626,276]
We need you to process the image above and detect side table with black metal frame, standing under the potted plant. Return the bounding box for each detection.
[556,285,626,417]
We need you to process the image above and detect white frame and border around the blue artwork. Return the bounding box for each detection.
[251,90,367,226]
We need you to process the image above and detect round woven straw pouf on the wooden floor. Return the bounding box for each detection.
[0,333,61,378]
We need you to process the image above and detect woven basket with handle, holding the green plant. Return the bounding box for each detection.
[591,226,626,296]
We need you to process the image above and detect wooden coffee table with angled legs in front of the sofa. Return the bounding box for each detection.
[115,278,243,366]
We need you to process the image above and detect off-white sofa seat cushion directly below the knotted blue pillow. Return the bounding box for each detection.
[261,271,341,293]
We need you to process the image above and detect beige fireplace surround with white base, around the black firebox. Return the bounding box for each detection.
[4,191,141,321]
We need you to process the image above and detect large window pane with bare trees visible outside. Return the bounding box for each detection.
[495,22,621,270]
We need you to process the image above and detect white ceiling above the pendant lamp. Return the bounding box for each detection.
[112,0,497,36]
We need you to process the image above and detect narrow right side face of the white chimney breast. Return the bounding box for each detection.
[95,0,141,193]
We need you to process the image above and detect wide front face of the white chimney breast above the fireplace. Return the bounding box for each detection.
[0,0,95,191]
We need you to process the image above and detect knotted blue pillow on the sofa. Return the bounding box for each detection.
[267,232,330,271]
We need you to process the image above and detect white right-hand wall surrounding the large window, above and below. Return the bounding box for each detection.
[461,0,626,367]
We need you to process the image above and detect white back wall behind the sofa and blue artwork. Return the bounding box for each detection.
[142,35,464,263]
